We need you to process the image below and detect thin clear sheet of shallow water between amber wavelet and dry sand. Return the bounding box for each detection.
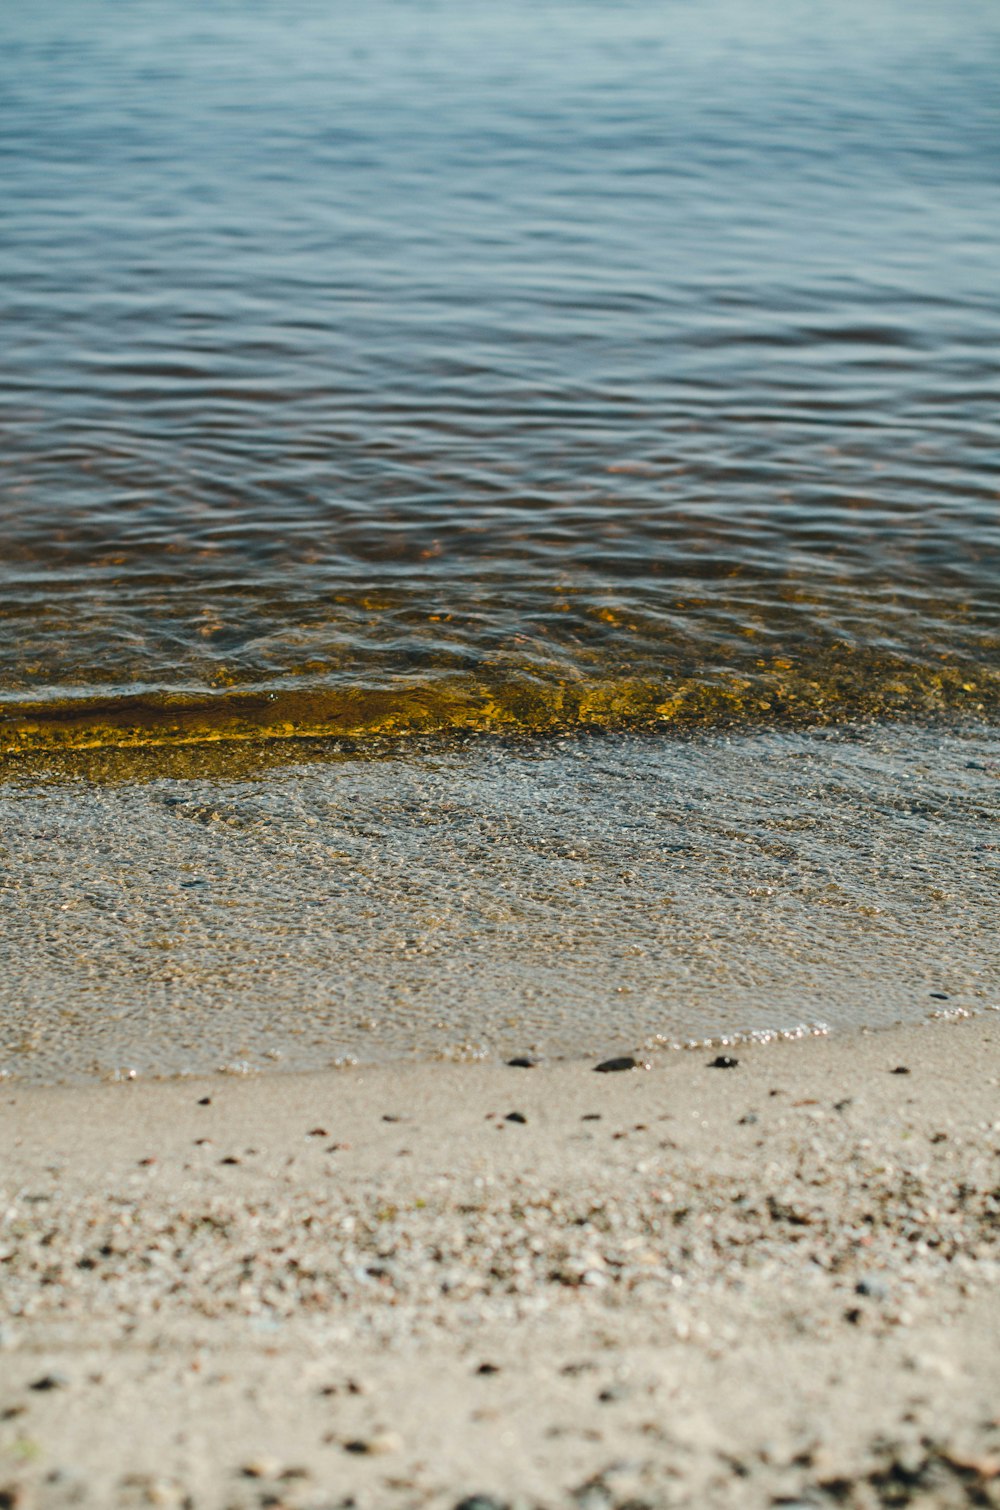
[0,726,1000,1081]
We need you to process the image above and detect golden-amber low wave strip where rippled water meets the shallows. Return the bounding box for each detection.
[0,651,1000,755]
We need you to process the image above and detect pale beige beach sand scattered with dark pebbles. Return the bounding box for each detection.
[0,1013,1000,1510]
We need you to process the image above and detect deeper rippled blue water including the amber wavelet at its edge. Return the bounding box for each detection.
[0,0,1000,750]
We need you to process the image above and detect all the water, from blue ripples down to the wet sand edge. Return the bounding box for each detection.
[0,0,1000,1080]
